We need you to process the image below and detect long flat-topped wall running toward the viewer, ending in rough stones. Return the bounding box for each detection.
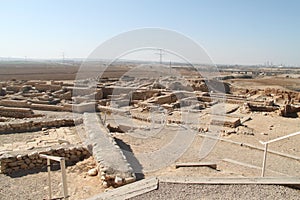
[83,113,136,187]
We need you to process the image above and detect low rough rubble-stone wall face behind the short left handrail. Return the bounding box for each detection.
[0,146,90,174]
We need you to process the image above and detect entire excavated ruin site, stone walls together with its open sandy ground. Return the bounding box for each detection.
[0,64,300,199]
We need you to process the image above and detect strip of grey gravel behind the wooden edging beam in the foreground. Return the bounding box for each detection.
[130,183,300,200]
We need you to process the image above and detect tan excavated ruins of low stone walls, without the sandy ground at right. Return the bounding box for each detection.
[0,64,300,197]
